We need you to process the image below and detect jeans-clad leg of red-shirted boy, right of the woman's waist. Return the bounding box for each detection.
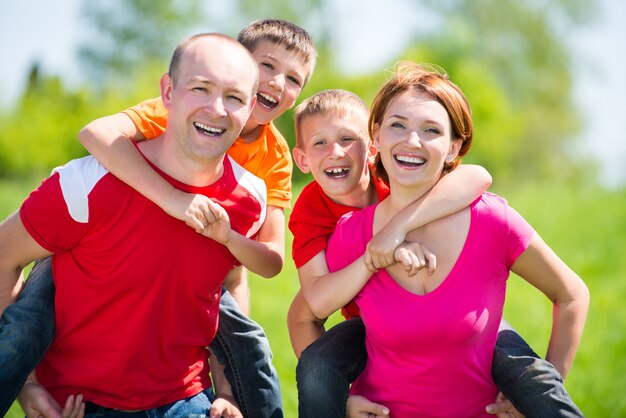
[491,320,583,418]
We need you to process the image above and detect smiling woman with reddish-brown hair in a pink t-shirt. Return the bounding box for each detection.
[309,63,589,418]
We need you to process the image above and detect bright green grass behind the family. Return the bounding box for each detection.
[0,181,626,417]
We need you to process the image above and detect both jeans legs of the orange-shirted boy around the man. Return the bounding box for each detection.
[0,258,283,418]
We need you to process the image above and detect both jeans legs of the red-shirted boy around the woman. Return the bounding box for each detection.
[296,319,583,418]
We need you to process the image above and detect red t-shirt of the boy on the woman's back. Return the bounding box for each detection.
[289,176,389,319]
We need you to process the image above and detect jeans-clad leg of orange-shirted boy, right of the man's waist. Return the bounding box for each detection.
[211,290,283,418]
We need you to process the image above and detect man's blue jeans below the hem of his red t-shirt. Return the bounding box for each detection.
[85,389,214,418]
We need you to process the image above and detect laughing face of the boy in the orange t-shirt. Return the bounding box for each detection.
[251,41,310,125]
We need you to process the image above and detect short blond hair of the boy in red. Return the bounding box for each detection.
[295,89,369,148]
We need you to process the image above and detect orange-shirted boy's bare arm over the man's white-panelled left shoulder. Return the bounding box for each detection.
[78,113,208,232]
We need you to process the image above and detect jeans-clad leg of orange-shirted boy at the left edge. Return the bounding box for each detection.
[0,257,54,416]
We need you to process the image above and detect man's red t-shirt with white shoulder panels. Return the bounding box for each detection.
[20,156,265,409]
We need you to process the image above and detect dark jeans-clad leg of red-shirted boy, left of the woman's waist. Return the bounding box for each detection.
[296,318,367,418]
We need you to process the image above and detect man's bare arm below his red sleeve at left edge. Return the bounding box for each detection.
[0,212,52,314]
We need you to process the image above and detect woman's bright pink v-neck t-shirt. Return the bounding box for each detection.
[326,193,534,418]
